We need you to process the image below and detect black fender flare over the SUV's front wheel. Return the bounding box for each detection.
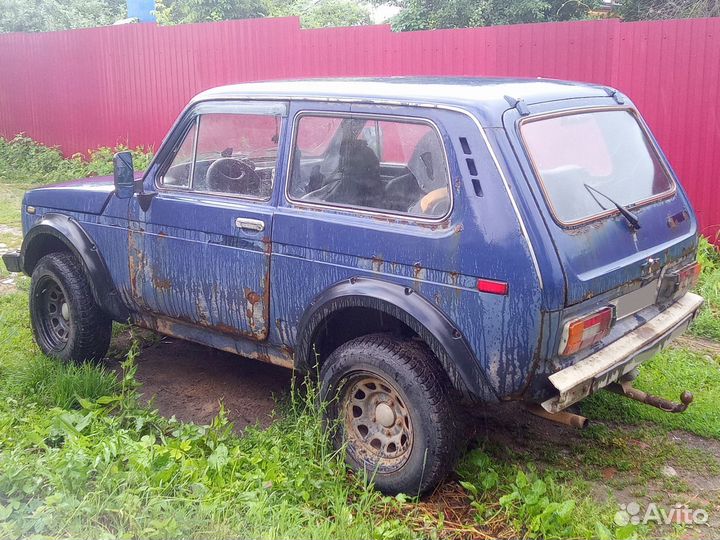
[20,212,130,321]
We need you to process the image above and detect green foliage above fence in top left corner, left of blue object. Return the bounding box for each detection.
[0,0,127,32]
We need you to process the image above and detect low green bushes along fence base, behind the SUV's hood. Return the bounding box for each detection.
[0,135,152,184]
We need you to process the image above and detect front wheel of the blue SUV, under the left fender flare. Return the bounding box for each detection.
[30,253,112,362]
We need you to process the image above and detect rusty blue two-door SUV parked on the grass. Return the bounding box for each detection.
[3,78,702,493]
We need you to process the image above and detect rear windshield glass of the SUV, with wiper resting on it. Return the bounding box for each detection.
[521,110,674,224]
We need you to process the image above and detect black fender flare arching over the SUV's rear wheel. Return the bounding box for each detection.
[295,277,498,401]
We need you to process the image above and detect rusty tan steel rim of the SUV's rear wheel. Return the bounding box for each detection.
[342,372,413,473]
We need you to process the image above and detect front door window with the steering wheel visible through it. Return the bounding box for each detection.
[163,113,281,199]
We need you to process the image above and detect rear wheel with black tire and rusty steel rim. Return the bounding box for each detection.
[320,334,458,495]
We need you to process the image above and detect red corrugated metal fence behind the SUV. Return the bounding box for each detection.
[0,18,720,235]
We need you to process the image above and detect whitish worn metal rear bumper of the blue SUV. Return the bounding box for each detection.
[542,293,703,413]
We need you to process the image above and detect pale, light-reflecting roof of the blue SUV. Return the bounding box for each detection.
[193,77,609,113]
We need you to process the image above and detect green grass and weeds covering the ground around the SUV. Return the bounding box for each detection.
[0,138,720,540]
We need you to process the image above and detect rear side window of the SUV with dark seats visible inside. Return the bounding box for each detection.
[289,115,451,219]
